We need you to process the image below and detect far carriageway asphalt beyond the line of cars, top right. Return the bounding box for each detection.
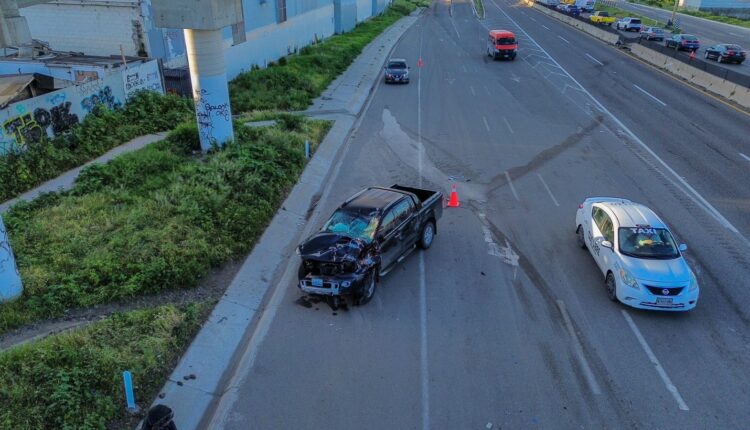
[615,1,750,75]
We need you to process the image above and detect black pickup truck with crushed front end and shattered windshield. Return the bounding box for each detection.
[297,185,443,308]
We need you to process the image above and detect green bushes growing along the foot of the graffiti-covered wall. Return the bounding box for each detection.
[0,92,193,202]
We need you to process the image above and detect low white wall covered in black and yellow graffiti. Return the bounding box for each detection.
[0,60,164,155]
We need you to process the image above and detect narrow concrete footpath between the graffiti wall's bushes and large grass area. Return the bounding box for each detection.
[0,132,167,214]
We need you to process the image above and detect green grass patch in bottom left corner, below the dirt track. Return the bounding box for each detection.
[0,303,213,430]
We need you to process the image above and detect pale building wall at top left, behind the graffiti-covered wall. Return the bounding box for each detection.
[21,0,147,56]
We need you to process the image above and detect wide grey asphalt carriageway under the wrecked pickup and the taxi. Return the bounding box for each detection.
[207,0,750,429]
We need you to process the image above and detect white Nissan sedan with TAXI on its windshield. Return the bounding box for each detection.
[576,197,699,311]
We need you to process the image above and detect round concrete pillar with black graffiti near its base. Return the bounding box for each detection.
[185,29,234,151]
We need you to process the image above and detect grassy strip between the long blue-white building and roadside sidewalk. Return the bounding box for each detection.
[229,0,429,114]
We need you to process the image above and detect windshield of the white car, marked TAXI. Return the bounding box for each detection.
[619,227,680,260]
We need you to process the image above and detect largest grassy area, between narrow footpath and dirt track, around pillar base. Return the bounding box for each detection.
[0,114,330,333]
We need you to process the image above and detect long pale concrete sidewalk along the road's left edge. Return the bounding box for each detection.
[154,13,418,430]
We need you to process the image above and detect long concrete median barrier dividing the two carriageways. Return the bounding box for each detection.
[534,4,750,109]
